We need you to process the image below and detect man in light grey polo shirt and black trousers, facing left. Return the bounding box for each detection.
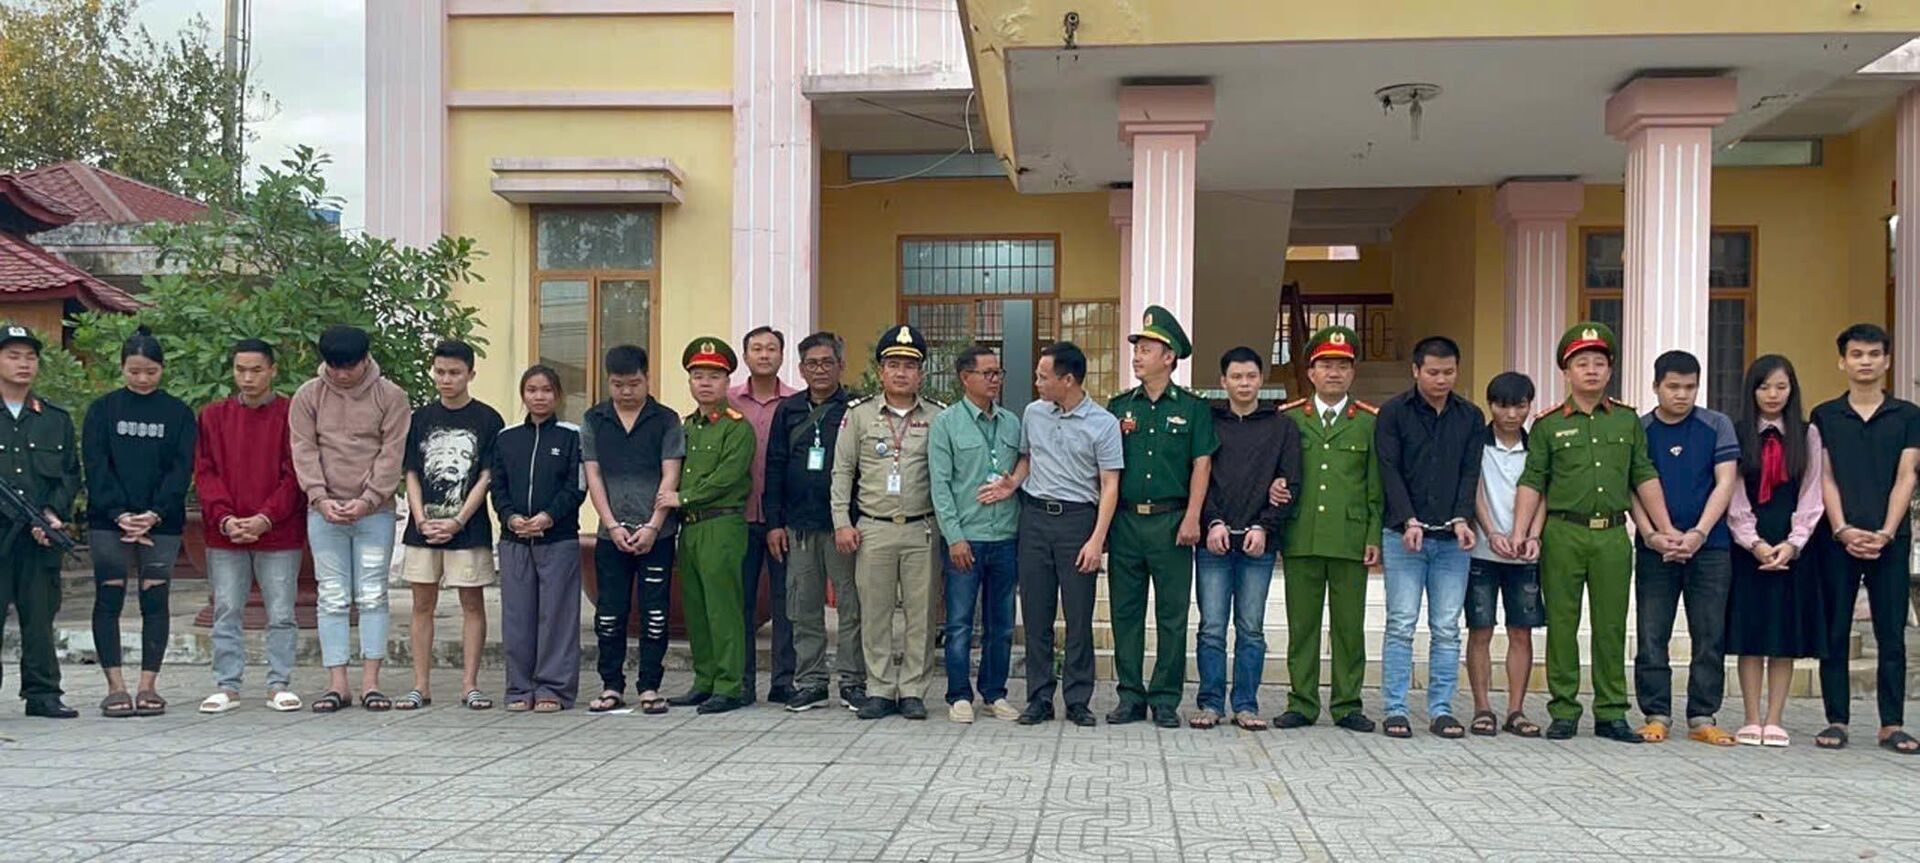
[1006,342,1125,727]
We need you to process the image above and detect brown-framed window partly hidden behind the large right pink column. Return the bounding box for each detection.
[1580,227,1761,413]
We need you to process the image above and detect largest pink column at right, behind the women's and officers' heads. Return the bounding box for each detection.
[1607,77,1736,404]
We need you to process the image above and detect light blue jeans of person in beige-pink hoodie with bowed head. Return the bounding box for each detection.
[307,509,394,669]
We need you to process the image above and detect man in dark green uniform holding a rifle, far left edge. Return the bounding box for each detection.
[0,323,81,719]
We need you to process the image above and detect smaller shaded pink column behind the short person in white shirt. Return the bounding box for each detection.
[1494,181,1586,407]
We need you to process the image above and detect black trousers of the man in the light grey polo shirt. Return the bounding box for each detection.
[1018,496,1098,707]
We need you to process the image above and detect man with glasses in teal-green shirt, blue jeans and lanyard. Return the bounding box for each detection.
[927,344,1020,723]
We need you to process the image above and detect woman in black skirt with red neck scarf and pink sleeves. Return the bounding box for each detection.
[1726,354,1826,746]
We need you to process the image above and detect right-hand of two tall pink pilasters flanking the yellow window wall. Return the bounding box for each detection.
[730,0,814,382]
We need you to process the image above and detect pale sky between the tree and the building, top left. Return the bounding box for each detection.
[138,0,367,229]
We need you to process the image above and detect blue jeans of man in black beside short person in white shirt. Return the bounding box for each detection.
[1380,530,1473,717]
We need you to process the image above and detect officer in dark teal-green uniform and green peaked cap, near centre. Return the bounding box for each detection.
[1106,306,1219,728]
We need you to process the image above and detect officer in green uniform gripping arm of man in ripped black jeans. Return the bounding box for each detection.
[659,336,755,713]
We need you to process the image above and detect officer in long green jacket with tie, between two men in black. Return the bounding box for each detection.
[1273,327,1384,732]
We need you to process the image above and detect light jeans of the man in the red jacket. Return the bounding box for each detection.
[207,548,301,692]
